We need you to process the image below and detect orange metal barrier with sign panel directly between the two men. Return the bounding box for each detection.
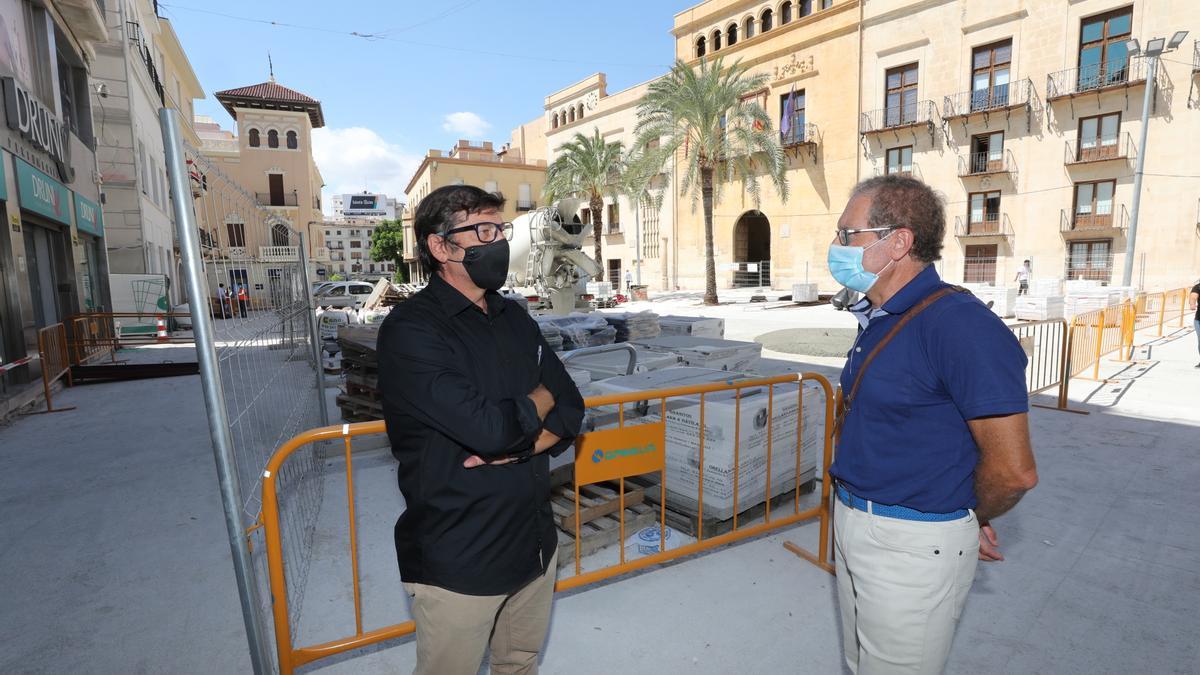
[260,374,834,675]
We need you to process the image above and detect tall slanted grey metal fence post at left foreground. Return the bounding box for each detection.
[158,108,270,675]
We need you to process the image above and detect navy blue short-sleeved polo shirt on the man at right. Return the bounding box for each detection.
[829,265,1030,513]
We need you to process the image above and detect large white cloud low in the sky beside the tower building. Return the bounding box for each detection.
[312,126,422,214]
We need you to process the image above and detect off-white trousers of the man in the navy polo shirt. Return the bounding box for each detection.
[834,500,979,675]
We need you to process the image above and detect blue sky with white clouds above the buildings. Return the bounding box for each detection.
[158,0,690,210]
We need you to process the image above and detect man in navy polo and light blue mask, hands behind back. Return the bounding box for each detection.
[829,175,1037,675]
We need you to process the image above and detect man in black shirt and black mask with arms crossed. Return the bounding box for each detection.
[378,185,583,675]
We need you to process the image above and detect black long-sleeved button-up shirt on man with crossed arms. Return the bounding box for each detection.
[378,275,583,596]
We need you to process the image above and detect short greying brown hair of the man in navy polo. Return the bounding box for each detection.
[850,175,946,263]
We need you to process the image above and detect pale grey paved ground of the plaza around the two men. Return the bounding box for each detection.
[0,294,1200,675]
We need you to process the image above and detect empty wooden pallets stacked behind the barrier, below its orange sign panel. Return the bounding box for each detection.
[551,482,659,567]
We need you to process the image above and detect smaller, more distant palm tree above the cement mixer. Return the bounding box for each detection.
[542,129,625,281]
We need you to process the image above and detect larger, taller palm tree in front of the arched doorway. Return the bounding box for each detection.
[634,56,787,305]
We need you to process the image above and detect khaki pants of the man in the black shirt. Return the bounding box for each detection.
[404,551,558,675]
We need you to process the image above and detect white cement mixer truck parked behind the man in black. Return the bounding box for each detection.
[509,199,600,313]
